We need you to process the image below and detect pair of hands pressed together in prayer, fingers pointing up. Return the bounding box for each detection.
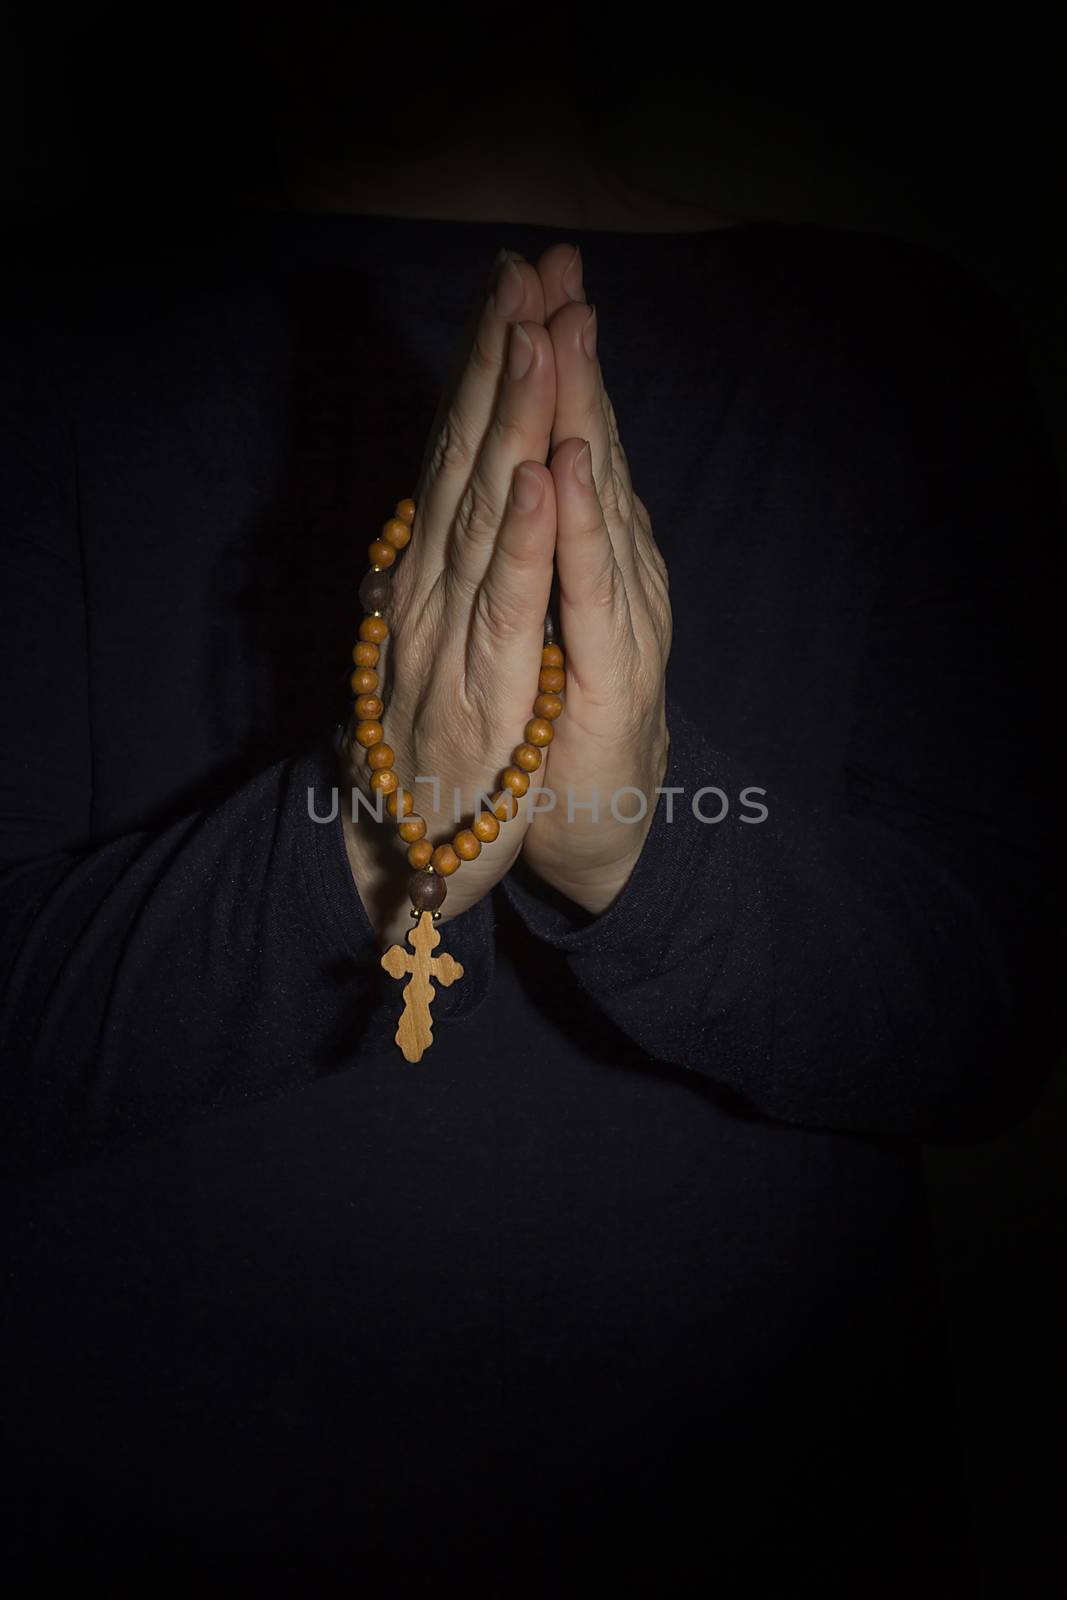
[341,245,670,942]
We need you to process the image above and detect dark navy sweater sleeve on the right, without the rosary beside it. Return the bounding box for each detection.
[507,278,1064,1142]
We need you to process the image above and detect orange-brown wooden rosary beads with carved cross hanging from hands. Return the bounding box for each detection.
[349,499,566,1061]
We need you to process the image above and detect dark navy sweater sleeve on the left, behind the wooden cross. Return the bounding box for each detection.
[0,324,488,1173]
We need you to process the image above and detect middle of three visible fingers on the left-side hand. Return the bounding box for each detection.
[448,322,555,603]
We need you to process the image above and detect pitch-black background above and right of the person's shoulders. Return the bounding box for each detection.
[0,6,1067,1600]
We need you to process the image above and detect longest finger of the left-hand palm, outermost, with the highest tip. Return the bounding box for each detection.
[414,251,544,568]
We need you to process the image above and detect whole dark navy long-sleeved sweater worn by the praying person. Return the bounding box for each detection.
[0,206,1062,1595]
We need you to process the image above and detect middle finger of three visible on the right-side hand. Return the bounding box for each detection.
[549,304,637,581]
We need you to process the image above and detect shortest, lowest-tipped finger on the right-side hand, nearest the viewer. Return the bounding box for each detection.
[550,438,633,690]
